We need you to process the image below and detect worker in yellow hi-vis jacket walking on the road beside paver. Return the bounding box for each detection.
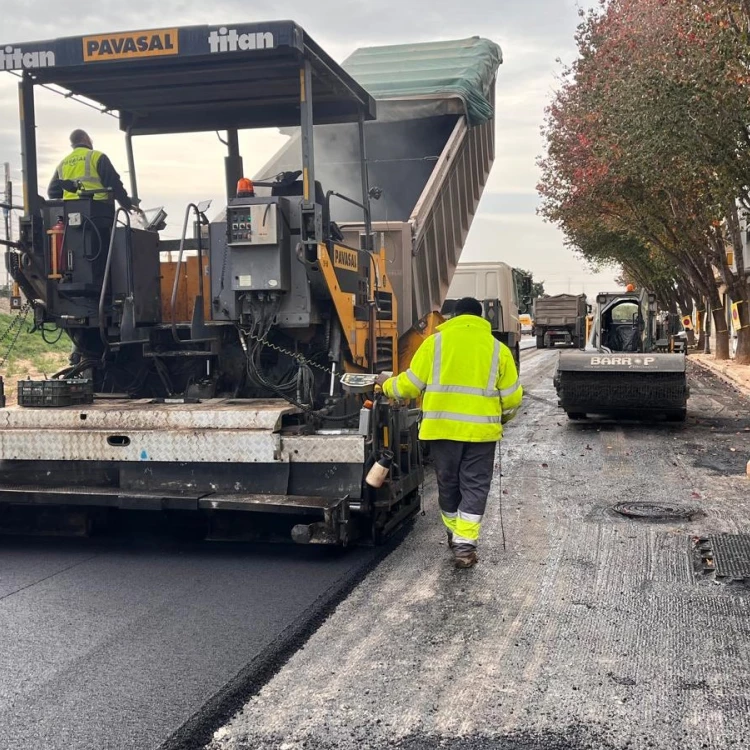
[378,297,523,568]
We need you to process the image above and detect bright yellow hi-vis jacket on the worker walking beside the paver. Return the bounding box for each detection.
[383,315,523,443]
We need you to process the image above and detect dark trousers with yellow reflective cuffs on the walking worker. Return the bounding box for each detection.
[430,440,497,554]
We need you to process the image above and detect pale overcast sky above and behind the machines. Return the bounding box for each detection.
[0,0,614,295]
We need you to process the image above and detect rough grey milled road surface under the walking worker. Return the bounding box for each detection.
[209,349,750,750]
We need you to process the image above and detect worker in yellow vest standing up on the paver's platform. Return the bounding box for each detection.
[47,130,137,211]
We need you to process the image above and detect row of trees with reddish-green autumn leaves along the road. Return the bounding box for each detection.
[538,0,750,364]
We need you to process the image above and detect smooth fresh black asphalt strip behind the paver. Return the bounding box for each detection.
[0,537,382,750]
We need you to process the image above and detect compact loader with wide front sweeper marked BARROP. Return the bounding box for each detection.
[554,290,690,422]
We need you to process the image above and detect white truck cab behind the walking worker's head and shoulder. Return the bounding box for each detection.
[441,261,531,368]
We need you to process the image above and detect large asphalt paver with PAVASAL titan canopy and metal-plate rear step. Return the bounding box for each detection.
[0,22,422,544]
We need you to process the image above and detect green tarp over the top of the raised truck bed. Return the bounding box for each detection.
[342,37,503,125]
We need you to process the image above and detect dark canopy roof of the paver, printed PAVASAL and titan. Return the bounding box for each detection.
[0,21,376,135]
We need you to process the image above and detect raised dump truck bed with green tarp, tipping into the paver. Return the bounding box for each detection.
[258,37,502,334]
